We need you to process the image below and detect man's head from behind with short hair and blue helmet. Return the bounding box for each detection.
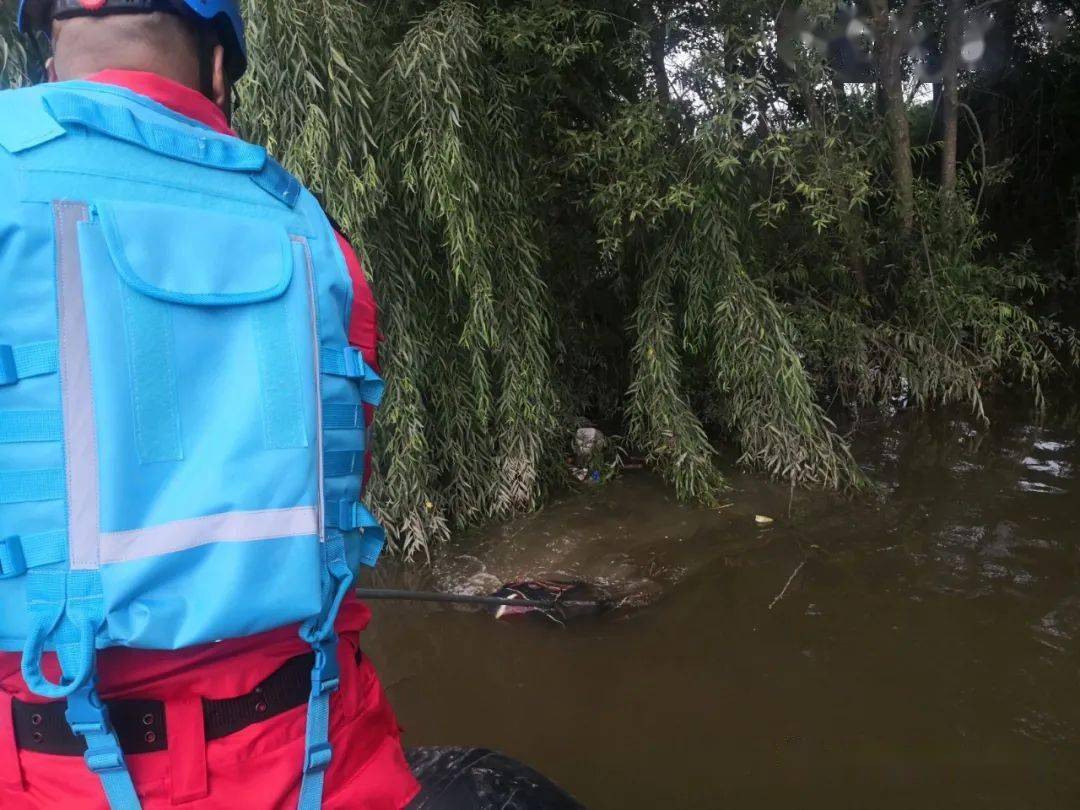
[19,0,246,113]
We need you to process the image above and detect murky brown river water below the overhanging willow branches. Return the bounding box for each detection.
[367,406,1080,810]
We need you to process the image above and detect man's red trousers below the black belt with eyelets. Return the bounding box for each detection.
[0,636,418,810]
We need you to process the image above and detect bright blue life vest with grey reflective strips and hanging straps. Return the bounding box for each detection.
[0,82,383,809]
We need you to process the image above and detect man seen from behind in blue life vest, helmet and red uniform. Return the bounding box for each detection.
[0,0,418,810]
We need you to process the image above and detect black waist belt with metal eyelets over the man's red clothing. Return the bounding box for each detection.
[12,652,315,756]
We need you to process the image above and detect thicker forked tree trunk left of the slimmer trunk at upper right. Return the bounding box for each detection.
[870,0,921,233]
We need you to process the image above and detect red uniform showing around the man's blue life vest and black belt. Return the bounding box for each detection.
[0,70,418,810]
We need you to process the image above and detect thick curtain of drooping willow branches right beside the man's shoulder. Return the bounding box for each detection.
[239,0,558,554]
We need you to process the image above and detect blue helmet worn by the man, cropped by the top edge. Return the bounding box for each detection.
[18,0,247,80]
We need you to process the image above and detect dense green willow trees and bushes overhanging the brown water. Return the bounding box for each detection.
[0,0,1080,554]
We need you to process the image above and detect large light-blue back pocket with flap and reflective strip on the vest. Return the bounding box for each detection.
[65,201,322,647]
